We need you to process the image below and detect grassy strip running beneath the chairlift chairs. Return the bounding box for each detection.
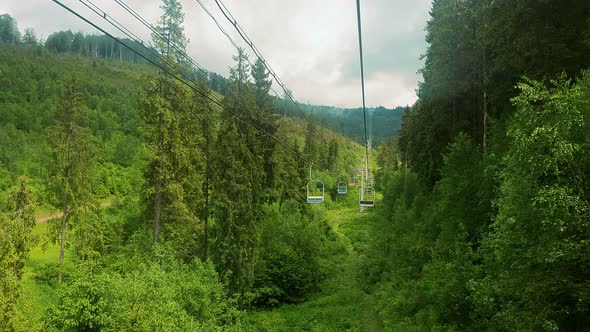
[249,191,383,331]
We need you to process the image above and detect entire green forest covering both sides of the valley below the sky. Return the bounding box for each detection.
[0,0,590,331]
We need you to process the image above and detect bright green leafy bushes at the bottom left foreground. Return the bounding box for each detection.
[47,256,239,331]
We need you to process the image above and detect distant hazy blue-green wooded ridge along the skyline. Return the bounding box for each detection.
[0,14,403,145]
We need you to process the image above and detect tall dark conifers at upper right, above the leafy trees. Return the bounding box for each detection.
[399,0,590,186]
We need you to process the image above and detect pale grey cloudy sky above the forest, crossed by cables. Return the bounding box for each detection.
[0,0,431,107]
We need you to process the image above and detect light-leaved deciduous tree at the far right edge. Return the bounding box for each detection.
[473,74,590,330]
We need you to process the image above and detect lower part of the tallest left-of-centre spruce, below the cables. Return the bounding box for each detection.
[142,80,202,249]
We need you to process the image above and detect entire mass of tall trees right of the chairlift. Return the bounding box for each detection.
[372,0,590,331]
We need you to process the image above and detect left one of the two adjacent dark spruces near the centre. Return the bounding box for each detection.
[213,49,264,305]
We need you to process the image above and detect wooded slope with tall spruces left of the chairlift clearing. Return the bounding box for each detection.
[0,0,364,331]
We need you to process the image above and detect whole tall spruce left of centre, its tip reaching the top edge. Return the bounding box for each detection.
[142,0,195,244]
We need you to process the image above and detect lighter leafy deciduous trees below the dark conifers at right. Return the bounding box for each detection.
[372,74,590,330]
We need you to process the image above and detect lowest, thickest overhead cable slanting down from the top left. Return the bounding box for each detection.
[52,0,307,161]
